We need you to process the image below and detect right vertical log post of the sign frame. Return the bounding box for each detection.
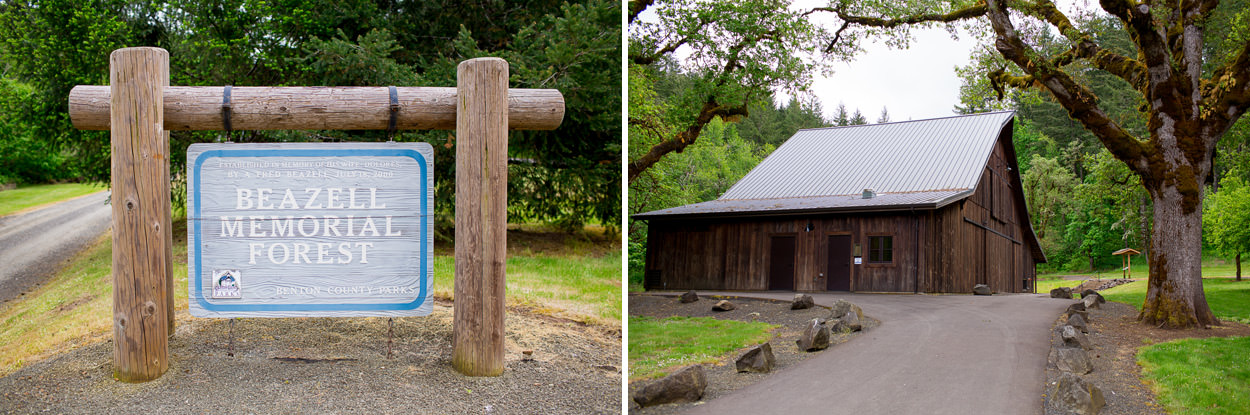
[451,58,508,376]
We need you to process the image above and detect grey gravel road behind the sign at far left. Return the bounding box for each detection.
[0,191,113,303]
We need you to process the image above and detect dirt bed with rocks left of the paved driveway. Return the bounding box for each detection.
[629,294,880,414]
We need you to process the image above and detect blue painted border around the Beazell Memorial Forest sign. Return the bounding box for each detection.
[191,149,433,313]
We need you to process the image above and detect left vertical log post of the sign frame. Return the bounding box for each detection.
[109,48,173,381]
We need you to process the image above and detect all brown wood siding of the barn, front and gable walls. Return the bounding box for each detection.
[646,126,1036,293]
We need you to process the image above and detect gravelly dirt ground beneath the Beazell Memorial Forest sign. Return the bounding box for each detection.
[0,304,621,414]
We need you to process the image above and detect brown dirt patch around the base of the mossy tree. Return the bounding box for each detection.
[1046,301,1250,415]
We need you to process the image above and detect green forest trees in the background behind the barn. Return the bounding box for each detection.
[629,1,1250,278]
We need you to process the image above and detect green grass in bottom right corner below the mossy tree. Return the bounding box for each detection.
[1138,338,1250,415]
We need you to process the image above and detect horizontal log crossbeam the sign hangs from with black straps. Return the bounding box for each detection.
[70,85,564,130]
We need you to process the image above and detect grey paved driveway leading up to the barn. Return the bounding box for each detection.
[688,291,1073,415]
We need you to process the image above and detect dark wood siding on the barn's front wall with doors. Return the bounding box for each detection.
[646,214,925,293]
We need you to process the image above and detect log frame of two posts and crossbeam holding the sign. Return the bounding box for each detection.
[63,48,564,381]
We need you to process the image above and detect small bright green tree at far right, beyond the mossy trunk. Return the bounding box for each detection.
[1203,178,1250,281]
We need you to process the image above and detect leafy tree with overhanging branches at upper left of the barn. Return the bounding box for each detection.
[628,0,825,183]
